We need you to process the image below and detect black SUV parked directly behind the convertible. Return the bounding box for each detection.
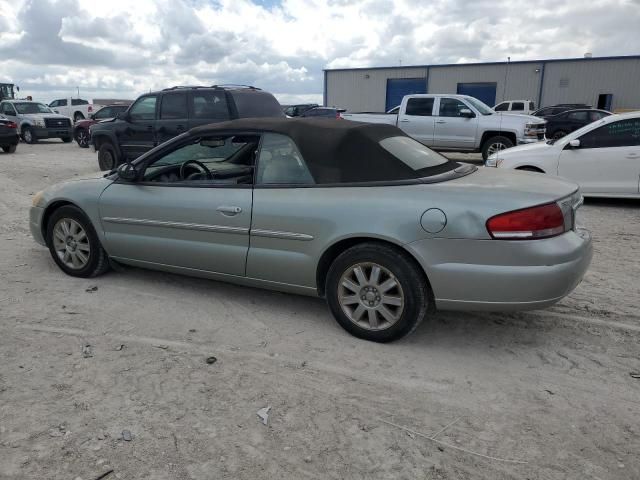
[90,85,285,170]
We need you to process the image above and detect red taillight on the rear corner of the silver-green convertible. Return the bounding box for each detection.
[487,202,573,240]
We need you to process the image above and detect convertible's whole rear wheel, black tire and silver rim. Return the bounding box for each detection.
[326,243,430,342]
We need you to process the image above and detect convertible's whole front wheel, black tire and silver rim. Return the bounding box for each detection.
[46,205,109,278]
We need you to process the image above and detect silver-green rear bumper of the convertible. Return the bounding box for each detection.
[406,230,593,311]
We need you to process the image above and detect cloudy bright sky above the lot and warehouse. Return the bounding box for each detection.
[0,0,640,104]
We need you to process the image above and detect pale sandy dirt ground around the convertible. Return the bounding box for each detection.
[0,140,640,480]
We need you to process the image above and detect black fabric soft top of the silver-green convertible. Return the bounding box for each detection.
[190,118,458,184]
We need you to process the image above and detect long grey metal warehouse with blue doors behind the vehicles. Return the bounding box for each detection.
[324,55,640,112]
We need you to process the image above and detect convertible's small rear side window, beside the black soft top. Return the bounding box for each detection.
[256,133,314,185]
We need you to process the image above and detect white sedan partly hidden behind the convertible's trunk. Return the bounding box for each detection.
[485,112,640,198]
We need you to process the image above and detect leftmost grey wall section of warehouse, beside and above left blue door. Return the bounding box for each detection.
[325,68,427,112]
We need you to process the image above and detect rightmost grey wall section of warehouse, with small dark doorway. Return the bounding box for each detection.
[542,59,640,110]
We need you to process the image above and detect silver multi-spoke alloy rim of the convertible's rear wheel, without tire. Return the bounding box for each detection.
[338,263,405,330]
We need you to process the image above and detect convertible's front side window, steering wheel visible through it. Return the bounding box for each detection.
[142,135,260,185]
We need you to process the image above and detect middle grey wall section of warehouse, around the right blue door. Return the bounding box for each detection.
[429,63,542,107]
